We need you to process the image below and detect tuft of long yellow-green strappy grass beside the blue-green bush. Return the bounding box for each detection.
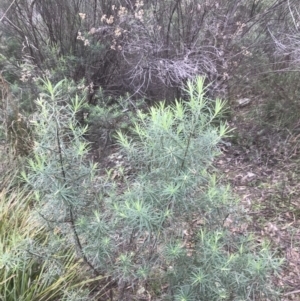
[0,183,99,301]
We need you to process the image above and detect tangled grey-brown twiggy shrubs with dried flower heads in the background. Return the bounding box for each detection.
[0,0,298,102]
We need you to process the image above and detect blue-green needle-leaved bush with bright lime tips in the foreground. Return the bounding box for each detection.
[22,78,280,300]
